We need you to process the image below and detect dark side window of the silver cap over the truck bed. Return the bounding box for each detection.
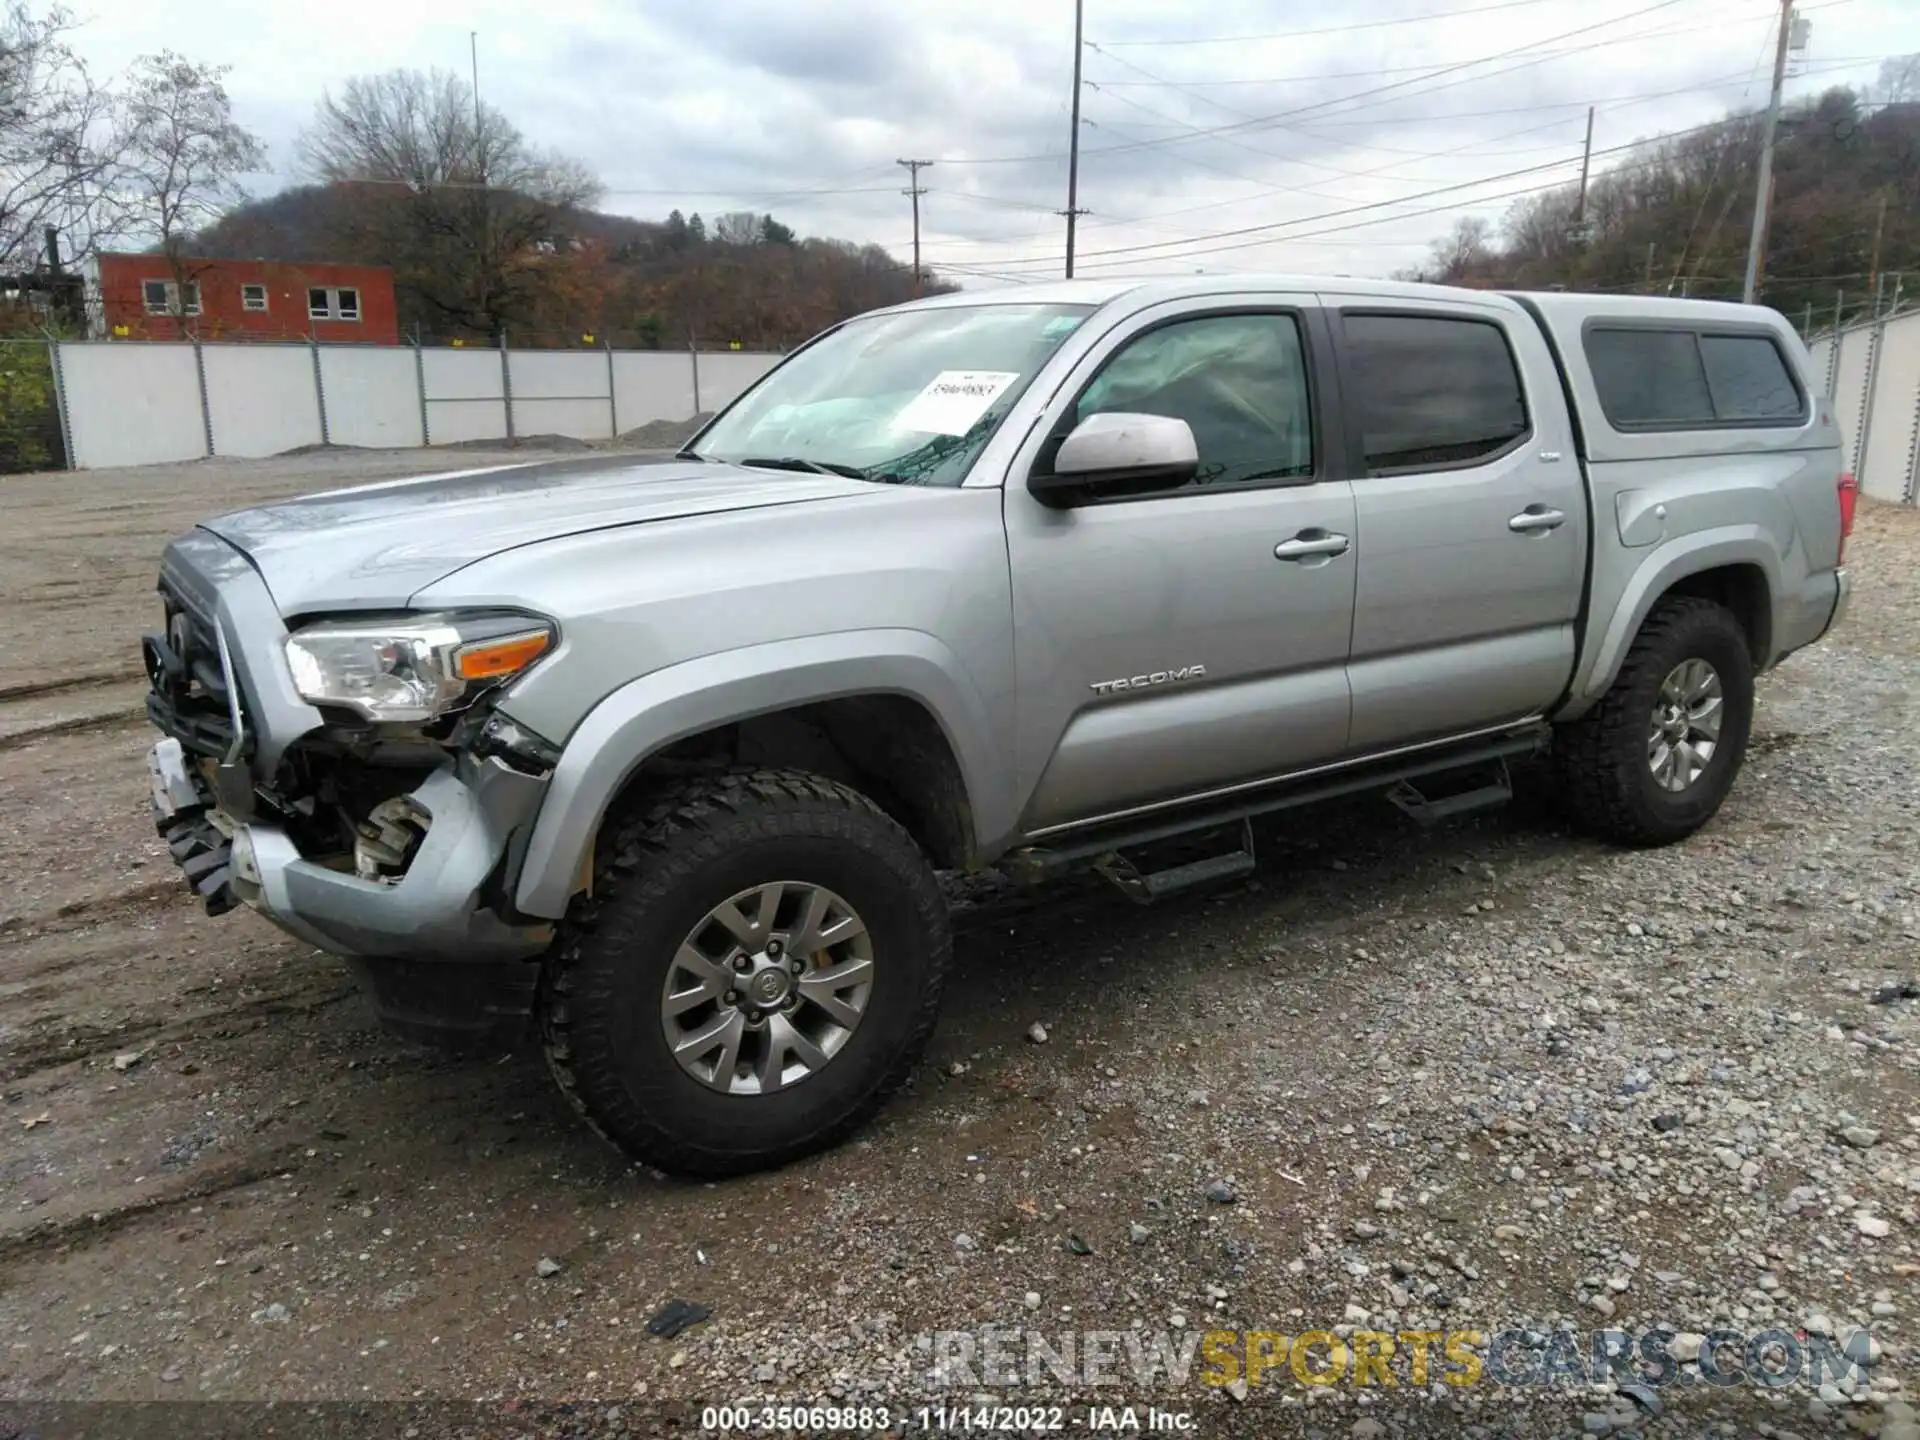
[1586,324,1807,430]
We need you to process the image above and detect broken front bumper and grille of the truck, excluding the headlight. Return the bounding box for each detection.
[144,536,553,1043]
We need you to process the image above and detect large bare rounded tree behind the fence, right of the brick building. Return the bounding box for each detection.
[300,69,599,336]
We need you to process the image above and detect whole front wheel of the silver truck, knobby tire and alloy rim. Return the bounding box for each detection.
[541,770,952,1175]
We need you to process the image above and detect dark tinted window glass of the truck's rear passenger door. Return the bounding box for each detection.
[1342,315,1530,474]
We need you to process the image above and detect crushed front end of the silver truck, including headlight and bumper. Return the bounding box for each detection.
[142,530,557,1043]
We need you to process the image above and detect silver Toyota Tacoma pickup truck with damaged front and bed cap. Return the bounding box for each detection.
[144,276,1853,1175]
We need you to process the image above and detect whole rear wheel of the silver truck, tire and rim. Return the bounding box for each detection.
[1553,595,1753,845]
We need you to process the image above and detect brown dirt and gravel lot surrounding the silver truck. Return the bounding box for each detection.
[0,453,1920,1440]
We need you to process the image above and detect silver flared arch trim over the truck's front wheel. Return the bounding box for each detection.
[501,630,1014,920]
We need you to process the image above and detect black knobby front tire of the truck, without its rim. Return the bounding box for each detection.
[540,770,952,1177]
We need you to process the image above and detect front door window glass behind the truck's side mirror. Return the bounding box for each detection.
[1073,315,1313,486]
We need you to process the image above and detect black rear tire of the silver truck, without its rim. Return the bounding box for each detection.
[1553,595,1753,847]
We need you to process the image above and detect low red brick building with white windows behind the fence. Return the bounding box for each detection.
[86,255,399,346]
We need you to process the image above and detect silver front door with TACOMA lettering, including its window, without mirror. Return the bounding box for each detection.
[1004,296,1357,835]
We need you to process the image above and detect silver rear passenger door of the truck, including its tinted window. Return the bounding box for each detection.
[1334,300,1588,753]
